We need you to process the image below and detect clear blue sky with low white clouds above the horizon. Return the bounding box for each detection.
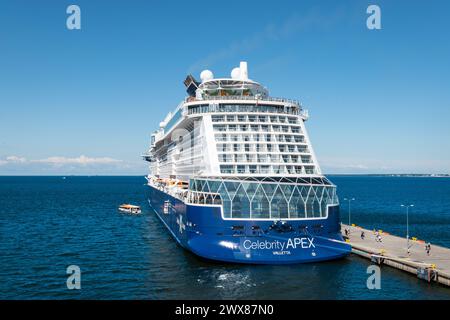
[0,0,450,175]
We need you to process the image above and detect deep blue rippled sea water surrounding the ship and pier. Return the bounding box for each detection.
[0,176,450,299]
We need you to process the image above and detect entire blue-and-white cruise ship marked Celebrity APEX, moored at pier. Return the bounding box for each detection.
[143,62,350,264]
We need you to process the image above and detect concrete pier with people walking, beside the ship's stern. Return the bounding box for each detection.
[342,224,450,286]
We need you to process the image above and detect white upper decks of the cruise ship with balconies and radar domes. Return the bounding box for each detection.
[145,62,322,181]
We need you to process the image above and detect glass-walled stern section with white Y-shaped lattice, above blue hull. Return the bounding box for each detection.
[188,177,339,220]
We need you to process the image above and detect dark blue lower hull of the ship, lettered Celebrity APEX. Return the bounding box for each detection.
[147,186,351,264]
